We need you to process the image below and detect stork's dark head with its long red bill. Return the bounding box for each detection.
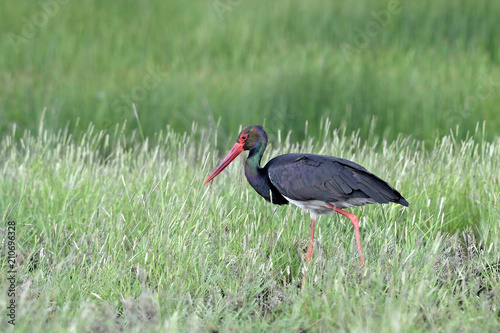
[205,125,267,184]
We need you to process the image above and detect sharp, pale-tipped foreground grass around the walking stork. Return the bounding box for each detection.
[0,121,500,332]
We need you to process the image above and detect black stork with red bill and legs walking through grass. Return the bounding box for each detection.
[205,125,409,282]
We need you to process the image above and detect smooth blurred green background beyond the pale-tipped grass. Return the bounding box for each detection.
[0,0,500,142]
